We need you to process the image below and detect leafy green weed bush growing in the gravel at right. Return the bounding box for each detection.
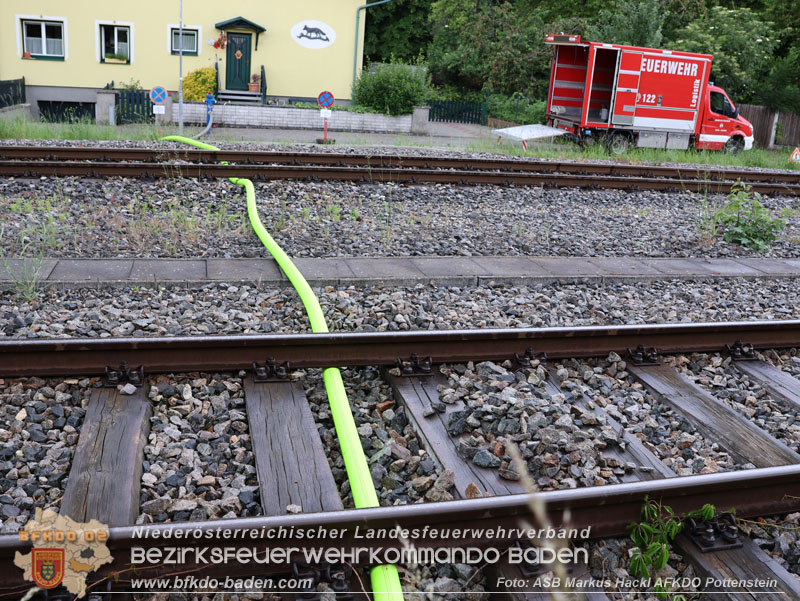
[717,182,786,251]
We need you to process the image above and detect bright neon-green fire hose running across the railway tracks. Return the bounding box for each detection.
[161,136,403,601]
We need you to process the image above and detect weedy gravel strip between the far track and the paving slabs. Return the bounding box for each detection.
[0,177,800,258]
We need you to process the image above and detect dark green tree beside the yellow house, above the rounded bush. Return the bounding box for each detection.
[364,0,433,63]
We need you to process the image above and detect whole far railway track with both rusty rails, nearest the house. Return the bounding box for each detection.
[0,146,800,196]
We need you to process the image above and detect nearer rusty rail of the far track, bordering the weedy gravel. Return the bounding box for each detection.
[0,161,800,196]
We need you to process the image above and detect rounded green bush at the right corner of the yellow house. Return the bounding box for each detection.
[353,63,429,115]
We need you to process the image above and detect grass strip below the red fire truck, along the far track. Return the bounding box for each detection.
[466,140,800,171]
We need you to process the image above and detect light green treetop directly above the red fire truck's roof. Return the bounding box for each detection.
[588,0,668,48]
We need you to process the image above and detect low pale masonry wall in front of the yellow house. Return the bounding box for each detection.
[172,102,412,133]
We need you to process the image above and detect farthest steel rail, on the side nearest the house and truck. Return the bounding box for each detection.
[0,146,800,184]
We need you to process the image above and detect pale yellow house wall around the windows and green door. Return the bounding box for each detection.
[0,0,364,99]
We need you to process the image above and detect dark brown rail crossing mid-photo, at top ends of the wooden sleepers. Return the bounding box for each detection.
[0,320,800,376]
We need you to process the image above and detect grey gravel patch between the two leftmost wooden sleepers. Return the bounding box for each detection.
[137,374,263,524]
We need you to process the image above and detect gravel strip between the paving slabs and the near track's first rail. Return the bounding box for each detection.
[0,278,800,338]
